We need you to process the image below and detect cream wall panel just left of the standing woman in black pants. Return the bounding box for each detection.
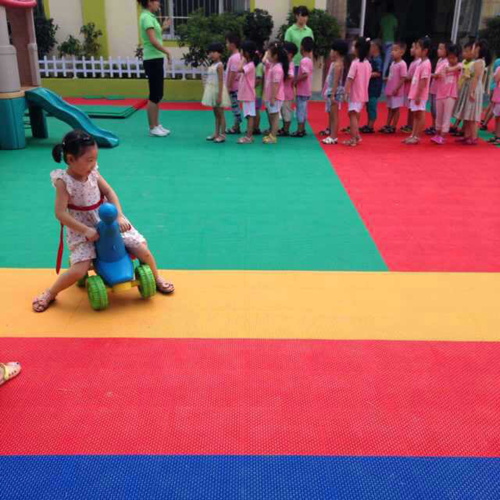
[106,0,139,57]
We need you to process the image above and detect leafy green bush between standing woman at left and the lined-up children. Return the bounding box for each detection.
[176,9,245,67]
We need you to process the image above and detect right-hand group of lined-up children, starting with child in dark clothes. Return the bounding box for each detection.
[346,38,500,145]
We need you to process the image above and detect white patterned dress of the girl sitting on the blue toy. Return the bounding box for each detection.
[50,167,146,264]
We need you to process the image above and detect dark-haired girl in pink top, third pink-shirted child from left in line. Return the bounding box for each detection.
[263,44,289,144]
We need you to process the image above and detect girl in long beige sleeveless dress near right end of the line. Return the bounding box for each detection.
[455,40,490,146]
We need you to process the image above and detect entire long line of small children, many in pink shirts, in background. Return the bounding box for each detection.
[202,35,500,146]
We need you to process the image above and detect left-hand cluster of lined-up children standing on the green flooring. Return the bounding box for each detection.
[202,35,314,144]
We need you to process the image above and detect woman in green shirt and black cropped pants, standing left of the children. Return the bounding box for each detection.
[137,0,172,137]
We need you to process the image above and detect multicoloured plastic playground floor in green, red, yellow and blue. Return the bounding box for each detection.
[0,103,500,500]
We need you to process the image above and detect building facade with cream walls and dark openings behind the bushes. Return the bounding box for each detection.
[43,0,500,57]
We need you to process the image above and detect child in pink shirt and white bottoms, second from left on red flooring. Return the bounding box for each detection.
[343,38,372,146]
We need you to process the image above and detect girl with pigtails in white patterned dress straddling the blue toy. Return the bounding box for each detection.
[33,130,174,312]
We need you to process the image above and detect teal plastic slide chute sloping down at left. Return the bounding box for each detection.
[26,87,120,148]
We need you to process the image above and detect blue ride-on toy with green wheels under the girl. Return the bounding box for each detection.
[78,203,156,311]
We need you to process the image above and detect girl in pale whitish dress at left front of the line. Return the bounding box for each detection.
[201,43,231,144]
